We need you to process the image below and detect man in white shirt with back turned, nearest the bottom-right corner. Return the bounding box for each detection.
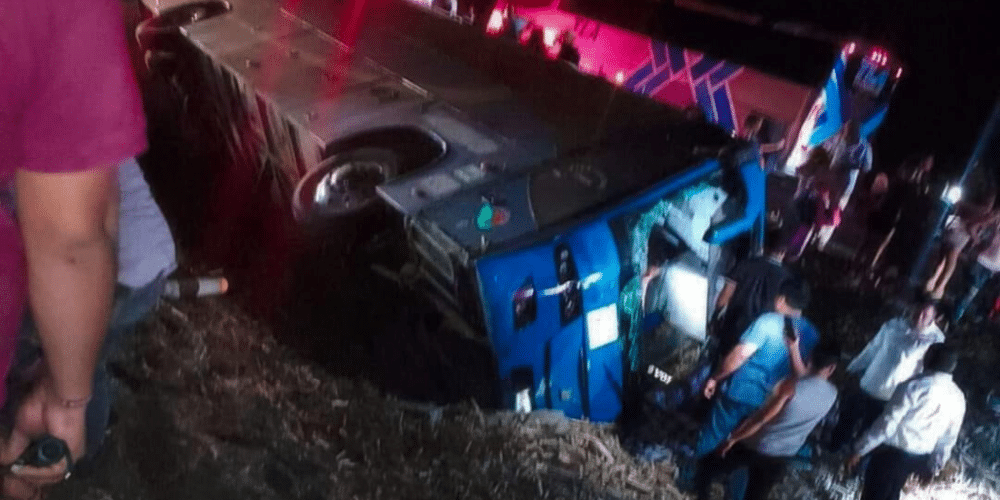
[846,344,965,500]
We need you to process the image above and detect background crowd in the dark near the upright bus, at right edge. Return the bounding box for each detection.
[752,107,1000,322]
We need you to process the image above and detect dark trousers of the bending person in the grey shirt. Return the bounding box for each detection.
[694,443,788,500]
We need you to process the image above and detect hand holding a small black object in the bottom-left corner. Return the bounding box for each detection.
[0,374,87,499]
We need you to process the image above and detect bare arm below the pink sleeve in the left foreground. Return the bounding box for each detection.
[16,166,118,457]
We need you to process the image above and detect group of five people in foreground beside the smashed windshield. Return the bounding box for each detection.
[694,229,965,500]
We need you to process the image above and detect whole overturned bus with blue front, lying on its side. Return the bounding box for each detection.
[138,0,765,421]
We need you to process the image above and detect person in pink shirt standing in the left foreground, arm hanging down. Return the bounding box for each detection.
[0,0,146,498]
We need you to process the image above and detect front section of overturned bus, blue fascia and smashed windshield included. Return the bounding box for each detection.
[379,123,765,421]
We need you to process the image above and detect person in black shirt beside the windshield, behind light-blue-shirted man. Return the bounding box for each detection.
[713,231,792,364]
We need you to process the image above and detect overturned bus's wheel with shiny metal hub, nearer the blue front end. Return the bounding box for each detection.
[293,148,400,222]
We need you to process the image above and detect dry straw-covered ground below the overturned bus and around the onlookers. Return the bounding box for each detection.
[29,252,1000,500]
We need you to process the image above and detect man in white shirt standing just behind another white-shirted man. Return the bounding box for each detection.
[832,299,944,450]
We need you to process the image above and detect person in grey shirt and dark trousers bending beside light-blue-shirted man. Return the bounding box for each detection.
[695,346,840,500]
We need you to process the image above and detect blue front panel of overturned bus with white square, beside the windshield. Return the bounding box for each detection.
[477,223,623,421]
